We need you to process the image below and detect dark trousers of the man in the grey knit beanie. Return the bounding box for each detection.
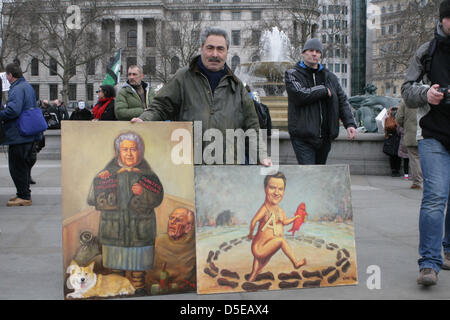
[291,137,331,164]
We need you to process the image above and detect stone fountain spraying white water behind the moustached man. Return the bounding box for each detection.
[236,27,293,130]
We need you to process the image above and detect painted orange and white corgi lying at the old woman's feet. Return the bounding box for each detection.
[66,260,135,299]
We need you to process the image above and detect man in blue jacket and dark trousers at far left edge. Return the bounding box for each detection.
[0,63,40,207]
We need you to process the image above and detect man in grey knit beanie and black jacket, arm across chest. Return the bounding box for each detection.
[285,39,356,164]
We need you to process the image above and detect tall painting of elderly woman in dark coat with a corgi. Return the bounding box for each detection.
[61,121,196,299]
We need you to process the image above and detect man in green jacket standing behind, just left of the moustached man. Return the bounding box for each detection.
[114,65,153,121]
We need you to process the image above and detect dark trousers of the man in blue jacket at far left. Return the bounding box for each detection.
[8,142,33,200]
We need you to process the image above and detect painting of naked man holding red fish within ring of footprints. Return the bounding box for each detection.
[195,165,358,294]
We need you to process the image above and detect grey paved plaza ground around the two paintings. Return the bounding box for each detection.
[0,158,450,300]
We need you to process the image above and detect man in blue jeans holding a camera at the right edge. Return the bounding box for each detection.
[402,0,450,286]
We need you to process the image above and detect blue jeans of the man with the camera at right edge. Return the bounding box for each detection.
[418,139,450,272]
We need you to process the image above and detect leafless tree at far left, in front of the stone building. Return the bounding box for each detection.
[5,0,111,103]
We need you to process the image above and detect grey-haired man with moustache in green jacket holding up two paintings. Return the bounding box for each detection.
[131,27,272,166]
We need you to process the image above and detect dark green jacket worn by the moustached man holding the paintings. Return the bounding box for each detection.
[139,56,265,163]
